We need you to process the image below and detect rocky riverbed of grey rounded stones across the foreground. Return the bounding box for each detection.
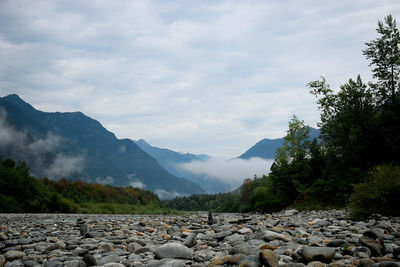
[0,210,400,267]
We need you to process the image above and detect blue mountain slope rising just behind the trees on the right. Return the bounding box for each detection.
[239,127,320,159]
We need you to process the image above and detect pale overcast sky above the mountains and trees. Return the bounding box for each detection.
[0,0,400,158]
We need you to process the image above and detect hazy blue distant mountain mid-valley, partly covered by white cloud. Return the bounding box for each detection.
[136,139,230,194]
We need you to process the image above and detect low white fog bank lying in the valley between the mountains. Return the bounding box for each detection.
[179,158,273,188]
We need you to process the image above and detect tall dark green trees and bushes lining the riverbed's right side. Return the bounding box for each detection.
[164,15,400,217]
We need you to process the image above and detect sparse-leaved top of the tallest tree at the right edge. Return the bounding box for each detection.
[363,15,400,104]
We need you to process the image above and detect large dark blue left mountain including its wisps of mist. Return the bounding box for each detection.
[0,95,205,198]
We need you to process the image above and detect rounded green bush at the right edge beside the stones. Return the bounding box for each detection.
[349,165,400,219]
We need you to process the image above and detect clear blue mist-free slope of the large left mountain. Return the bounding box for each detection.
[0,94,205,198]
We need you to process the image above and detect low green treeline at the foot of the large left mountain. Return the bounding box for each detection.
[0,158,162,213]
